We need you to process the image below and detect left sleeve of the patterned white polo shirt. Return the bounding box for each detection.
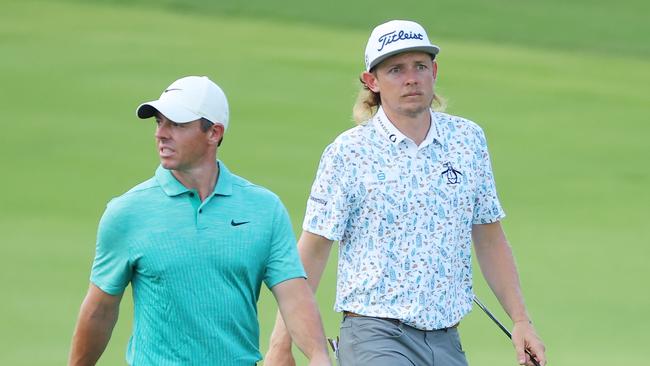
[302,144,352,240]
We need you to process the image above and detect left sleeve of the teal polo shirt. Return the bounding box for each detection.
[90,203,133,295]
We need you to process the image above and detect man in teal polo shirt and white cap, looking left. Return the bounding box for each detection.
[70,76,330,365]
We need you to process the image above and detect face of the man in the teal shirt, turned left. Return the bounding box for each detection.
[155,113,215,171]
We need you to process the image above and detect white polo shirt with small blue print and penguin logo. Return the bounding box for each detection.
[303,108,505,330]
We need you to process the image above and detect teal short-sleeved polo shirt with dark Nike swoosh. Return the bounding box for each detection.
[91,161,305,366]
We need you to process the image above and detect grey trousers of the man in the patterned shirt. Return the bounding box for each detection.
[338,316,467,366]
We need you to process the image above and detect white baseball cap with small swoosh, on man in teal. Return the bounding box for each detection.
[136,76,229,130]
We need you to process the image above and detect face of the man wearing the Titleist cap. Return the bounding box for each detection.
[362,52,437,117]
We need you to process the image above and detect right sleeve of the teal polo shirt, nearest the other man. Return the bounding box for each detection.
[264,201,307,289]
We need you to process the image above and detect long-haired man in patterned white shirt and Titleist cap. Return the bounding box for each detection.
[265,21,546,366]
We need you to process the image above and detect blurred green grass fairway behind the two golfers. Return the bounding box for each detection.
[0,0,650,366]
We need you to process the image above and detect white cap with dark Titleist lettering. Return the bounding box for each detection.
[366,20,440,71]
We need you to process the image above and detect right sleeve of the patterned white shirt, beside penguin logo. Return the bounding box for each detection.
[472,128,506,224]
